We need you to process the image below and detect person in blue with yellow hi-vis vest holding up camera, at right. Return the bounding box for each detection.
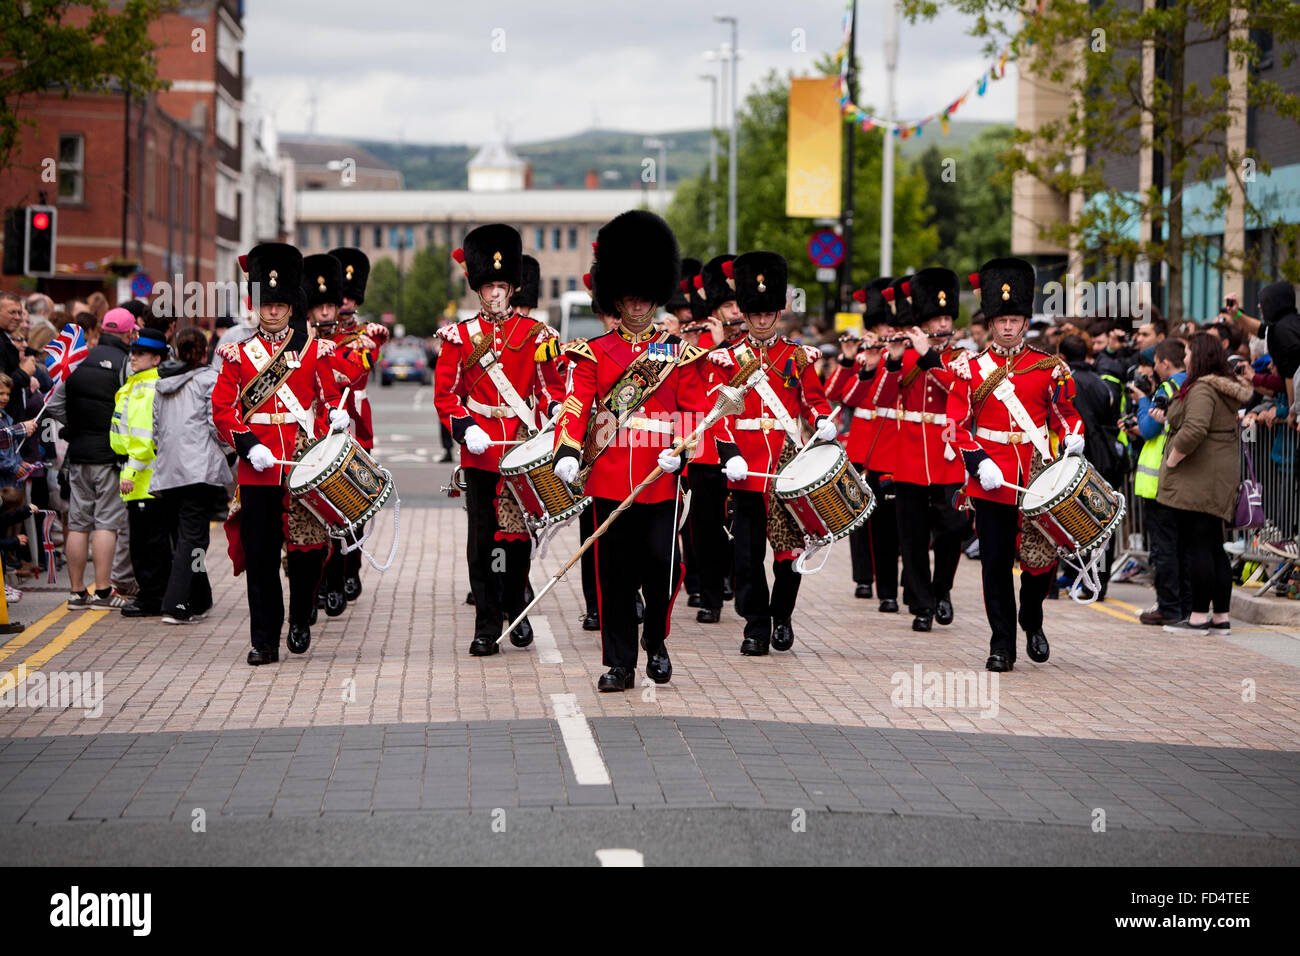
[1128,338,1191,626]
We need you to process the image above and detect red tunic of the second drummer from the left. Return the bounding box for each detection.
[433,312,556,471]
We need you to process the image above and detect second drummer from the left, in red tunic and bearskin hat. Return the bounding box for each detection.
[434,222,559,657]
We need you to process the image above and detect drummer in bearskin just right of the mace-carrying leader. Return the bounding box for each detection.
[709,252,836,657]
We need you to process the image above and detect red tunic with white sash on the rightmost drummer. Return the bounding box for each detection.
[946,346,1083,505]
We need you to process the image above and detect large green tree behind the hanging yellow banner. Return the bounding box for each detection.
[668,64,939,321]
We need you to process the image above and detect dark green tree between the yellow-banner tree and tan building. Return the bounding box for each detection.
[917,126,1014,277]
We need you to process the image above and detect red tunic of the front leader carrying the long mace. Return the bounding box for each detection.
[555,328,714,503]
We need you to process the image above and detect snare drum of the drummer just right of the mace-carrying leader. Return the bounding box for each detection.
[774,442,876,545]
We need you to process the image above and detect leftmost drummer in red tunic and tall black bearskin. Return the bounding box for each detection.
[212,242,350,666]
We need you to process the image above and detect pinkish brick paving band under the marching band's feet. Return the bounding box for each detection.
[0,507,1300,750]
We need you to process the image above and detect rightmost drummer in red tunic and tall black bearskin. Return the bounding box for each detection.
[946,259,1083,671]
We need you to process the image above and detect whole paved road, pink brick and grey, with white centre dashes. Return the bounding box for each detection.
[0,385,1300,865]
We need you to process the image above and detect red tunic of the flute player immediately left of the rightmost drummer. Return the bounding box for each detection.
[875,349,966,485]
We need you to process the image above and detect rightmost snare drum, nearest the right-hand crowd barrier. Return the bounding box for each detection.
[1021,455,1125,555]
